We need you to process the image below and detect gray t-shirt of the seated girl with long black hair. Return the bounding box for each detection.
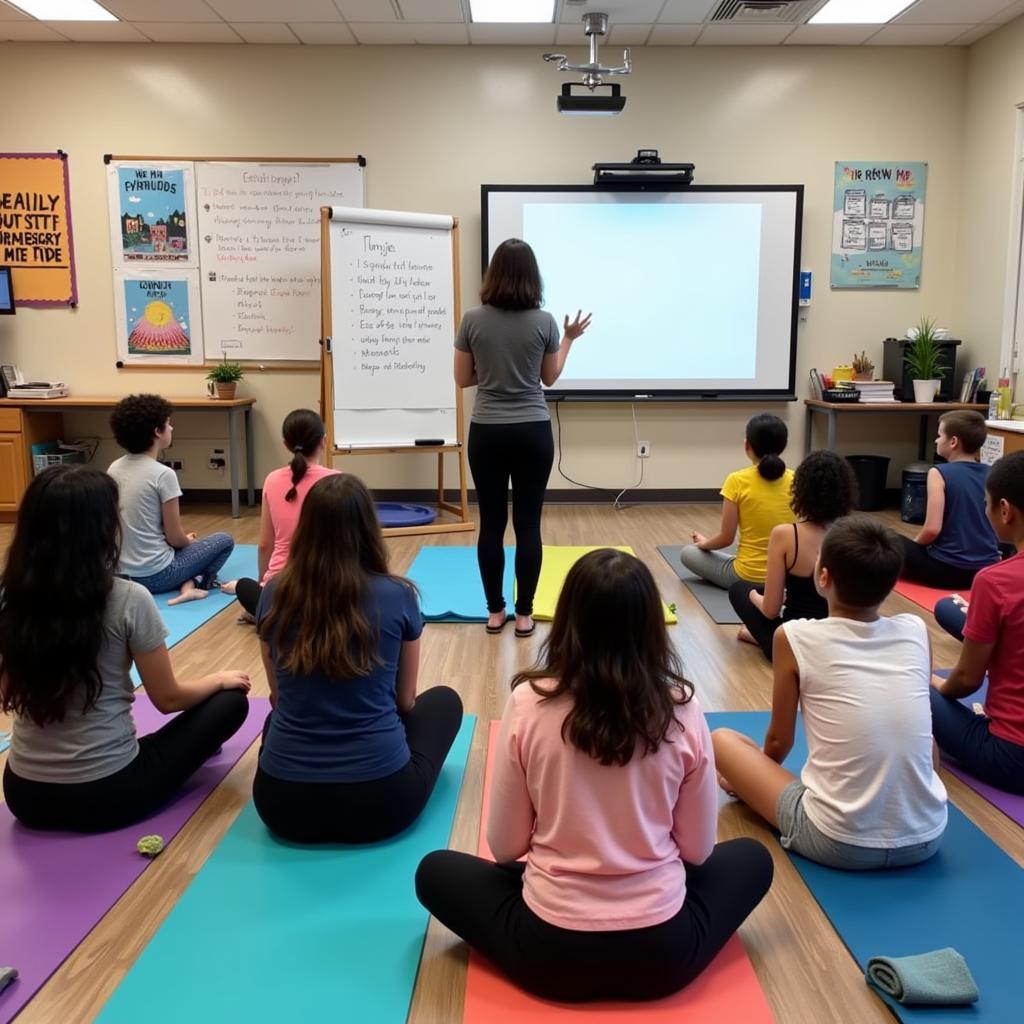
[8,579,167,782]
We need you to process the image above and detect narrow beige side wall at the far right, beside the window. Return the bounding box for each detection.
[954,17,1024,393]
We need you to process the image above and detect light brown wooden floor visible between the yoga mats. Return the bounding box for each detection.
[0,505,1024,1024]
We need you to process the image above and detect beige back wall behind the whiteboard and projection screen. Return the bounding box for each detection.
[0,36,983,488]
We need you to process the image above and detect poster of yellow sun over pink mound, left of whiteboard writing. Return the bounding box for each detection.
[114,267,204,364]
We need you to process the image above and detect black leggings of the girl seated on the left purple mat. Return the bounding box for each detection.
[3,690,249,831]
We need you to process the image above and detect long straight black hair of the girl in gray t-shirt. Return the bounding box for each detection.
[0,465,121,726]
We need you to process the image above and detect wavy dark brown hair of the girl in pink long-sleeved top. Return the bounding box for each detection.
[512,548,693,765]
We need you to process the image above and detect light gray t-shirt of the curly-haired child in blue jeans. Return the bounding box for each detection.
[106,455,181,580]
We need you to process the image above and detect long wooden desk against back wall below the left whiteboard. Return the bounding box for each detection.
[0,395,256,519]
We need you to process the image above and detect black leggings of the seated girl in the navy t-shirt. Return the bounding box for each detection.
[253,686,462,843]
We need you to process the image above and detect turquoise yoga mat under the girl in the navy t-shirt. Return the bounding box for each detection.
[98,716,475,1024]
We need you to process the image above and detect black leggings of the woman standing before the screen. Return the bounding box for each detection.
[467,420,555,615]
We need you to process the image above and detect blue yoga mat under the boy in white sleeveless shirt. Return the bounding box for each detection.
[708,712,1024,1024]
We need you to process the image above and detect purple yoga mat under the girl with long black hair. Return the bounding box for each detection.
[0,692,270,1024]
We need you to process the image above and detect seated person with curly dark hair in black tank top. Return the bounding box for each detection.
[729,452,857,662]
